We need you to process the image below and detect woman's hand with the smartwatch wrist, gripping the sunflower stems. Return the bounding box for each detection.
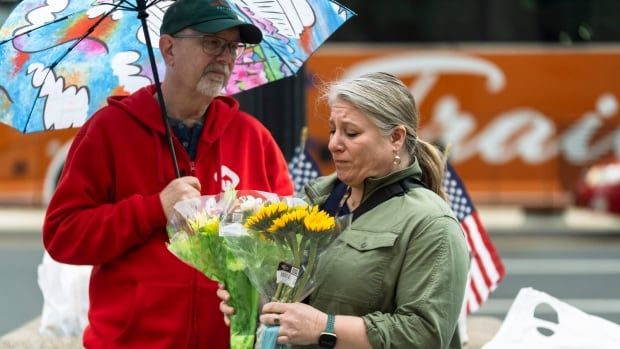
[260,300,327,345]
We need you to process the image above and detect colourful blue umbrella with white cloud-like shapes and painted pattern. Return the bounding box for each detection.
[0,0,355,174]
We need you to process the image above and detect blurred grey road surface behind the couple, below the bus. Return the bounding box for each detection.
[0,224,620,335]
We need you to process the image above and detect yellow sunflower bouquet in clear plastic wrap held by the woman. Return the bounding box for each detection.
[220,193,351,349]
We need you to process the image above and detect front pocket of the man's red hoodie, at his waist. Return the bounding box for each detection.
[115,283,191,348]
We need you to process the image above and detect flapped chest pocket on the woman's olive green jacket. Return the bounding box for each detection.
[316,231,398,315]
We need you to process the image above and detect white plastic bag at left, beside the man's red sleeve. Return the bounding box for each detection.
[38,252,92,337]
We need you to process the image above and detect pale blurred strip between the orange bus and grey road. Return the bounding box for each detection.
[0,206,620,237]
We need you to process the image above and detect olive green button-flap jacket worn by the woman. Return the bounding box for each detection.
[305,163,469,349]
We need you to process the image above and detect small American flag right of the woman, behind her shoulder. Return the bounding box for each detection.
[443,163,505,314]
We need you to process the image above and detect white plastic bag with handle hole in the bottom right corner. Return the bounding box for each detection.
[483,288,620,349]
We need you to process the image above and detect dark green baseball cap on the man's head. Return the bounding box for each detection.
[159,0,263,44]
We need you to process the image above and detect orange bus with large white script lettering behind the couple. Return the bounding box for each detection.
[0,44,620,209]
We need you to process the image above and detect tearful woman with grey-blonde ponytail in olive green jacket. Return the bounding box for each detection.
[218,73,469,349]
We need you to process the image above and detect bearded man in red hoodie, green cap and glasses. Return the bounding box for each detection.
[43,0,293,349]
